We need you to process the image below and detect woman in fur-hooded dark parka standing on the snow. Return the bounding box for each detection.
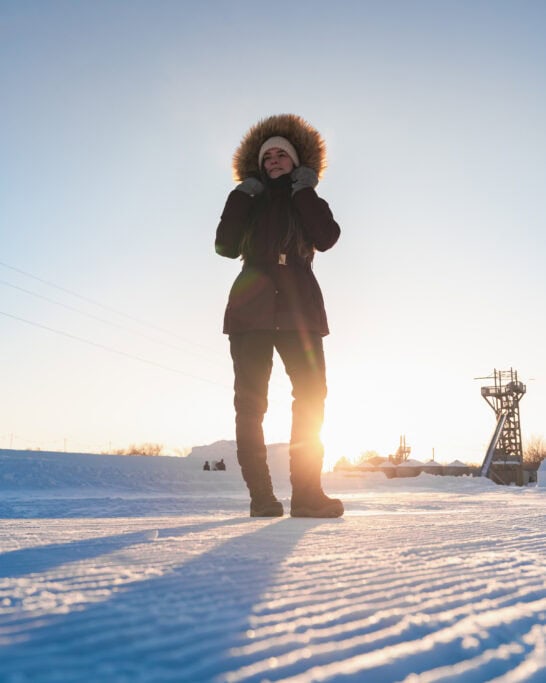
[215,114,343,517]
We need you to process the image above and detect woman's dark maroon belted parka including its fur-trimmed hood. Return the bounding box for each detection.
[215,114,340,335]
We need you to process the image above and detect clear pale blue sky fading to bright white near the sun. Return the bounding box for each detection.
[0,0,546,460]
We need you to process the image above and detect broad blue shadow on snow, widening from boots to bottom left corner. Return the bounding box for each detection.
[0,519,328,683]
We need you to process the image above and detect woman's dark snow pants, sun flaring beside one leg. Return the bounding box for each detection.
[229,331,326,497]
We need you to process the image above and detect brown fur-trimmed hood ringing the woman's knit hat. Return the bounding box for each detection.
[233,114,326,182]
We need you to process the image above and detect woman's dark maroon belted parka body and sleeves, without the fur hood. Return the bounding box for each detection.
[216,176,340,335]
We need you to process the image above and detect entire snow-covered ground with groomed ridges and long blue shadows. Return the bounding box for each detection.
[0,442,546,683]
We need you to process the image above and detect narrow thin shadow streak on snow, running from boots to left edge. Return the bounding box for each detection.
[0,517,249,579]
